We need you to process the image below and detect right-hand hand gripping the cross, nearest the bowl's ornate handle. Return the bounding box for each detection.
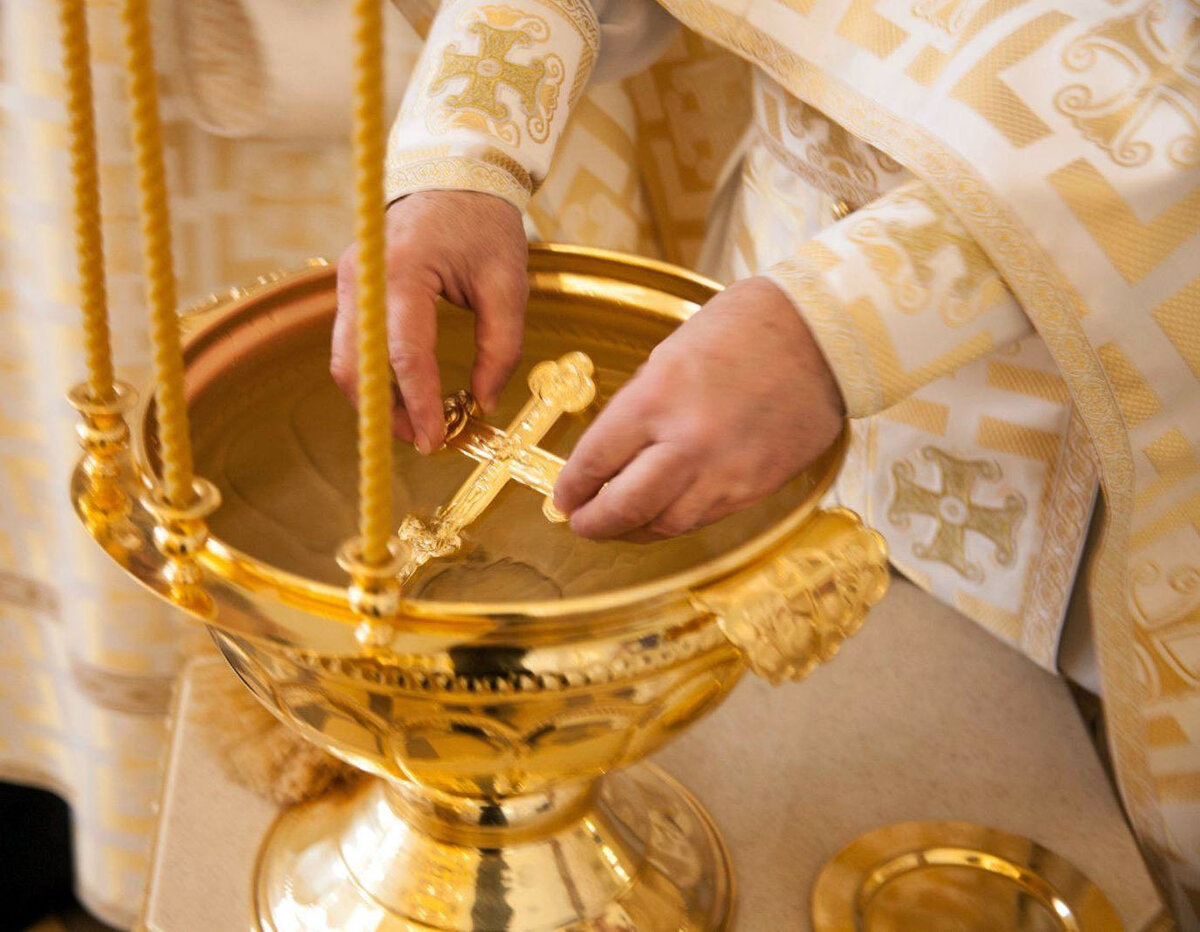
[554,278,845,542]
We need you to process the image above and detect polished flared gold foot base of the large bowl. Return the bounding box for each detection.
[254,764,733,932]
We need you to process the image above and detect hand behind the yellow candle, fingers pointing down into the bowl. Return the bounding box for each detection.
[330,191,529,453]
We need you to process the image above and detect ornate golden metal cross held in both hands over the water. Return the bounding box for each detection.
[398,353,596,583]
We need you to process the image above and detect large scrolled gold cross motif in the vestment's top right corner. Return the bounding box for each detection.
[1055,0,1200,169]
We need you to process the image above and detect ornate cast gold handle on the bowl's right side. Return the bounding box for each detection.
[692,509,888,684]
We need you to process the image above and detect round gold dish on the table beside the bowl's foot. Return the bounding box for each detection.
[812,822,1122,932]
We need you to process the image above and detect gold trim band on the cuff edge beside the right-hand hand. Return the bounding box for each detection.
[764,247,884,417]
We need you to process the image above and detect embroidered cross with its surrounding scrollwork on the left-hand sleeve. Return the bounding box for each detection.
[430,7,564,145]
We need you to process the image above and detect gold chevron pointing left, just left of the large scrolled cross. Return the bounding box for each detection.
[953,10,1072,148]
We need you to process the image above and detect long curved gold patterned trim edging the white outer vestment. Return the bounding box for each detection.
[660,0,1171,878]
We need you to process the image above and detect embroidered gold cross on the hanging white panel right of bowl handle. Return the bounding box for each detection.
[888,446,1025,583]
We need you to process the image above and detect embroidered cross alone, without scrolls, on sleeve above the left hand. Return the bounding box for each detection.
[430,23,546,120]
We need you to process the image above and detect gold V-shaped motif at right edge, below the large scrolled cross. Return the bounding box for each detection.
[1049,158,1200,284]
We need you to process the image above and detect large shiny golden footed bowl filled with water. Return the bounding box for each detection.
[73,246,887,932]
